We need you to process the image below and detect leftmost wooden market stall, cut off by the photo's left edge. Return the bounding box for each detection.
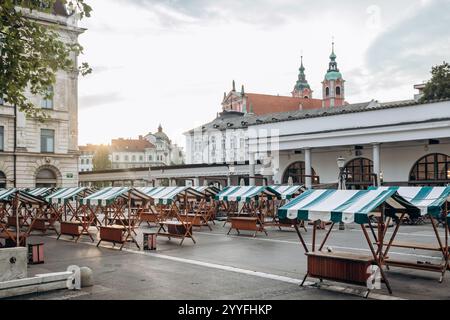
[0,188,46,246]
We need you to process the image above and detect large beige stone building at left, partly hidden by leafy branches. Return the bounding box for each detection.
[0,2,84,188]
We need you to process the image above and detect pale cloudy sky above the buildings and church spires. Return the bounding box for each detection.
[79,0,450,146]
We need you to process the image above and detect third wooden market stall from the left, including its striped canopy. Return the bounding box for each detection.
[75,187,150,249]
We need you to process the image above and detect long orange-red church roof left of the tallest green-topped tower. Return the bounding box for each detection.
[245,93,322,115]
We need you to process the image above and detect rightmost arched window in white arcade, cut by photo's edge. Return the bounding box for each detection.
[409,153,450,185]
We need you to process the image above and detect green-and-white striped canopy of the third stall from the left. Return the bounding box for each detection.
[80,187,150,206]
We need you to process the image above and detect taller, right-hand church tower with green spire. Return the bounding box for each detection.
[322,42,345,108]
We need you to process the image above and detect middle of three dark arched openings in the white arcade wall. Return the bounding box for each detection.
[345,158,373,189]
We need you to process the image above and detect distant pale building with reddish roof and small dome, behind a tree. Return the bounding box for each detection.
[80,125,184,172]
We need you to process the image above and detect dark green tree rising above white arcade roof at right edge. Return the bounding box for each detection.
[421,61,450,101]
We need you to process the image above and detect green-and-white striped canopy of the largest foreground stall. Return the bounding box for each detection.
[278,190,409,224]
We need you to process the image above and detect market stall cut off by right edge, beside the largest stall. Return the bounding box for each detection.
[372,187,450,282]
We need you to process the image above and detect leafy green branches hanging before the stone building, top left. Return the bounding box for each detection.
[0,0,91,118]
